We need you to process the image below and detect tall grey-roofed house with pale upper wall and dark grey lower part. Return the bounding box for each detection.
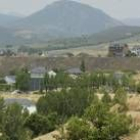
[29,67,47,91]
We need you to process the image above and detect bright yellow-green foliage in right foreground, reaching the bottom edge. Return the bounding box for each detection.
[67,101,132,140]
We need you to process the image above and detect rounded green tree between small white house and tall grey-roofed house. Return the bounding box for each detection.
[16,69,30,91]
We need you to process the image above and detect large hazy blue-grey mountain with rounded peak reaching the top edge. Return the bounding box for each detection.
[13,0,121,37]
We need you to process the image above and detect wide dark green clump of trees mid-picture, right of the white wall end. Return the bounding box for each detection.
[37,88,94,121]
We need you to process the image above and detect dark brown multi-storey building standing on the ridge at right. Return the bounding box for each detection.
[108,44,129,57]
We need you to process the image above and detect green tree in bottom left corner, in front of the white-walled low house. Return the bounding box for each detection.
[2,103,30,140]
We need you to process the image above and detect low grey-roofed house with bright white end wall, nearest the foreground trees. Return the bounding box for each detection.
[4,98,37,114]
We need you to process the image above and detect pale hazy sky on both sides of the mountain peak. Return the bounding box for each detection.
[0,0,140,19]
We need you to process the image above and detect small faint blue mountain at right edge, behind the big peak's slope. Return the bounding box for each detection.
[122,18,140,26]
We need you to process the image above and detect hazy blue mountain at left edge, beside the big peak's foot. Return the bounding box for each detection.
[0,14,21,27]
